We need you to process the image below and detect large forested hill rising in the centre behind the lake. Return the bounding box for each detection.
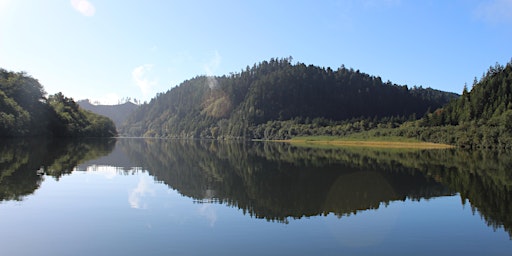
[121,58,458,139]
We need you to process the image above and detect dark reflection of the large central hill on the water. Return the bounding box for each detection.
[119,140,451,221]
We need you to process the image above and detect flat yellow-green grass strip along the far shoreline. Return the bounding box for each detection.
[283,136,453,149]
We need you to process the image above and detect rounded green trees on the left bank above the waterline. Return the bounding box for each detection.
[0,69,117,137]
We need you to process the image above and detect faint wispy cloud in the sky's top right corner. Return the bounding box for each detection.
[475,0,512,23]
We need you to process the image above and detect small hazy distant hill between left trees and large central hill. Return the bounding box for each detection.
[77,100,138,127]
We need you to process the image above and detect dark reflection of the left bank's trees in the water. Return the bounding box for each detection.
[0,138,115,201]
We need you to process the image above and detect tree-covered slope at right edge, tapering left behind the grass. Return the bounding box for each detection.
[356,61,512,149]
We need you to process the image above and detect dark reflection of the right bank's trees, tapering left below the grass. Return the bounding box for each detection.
[266,146,512,237]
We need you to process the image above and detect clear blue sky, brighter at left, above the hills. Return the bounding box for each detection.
[0,0,512,104]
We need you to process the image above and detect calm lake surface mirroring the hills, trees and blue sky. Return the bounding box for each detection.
[0,139,512,255]
